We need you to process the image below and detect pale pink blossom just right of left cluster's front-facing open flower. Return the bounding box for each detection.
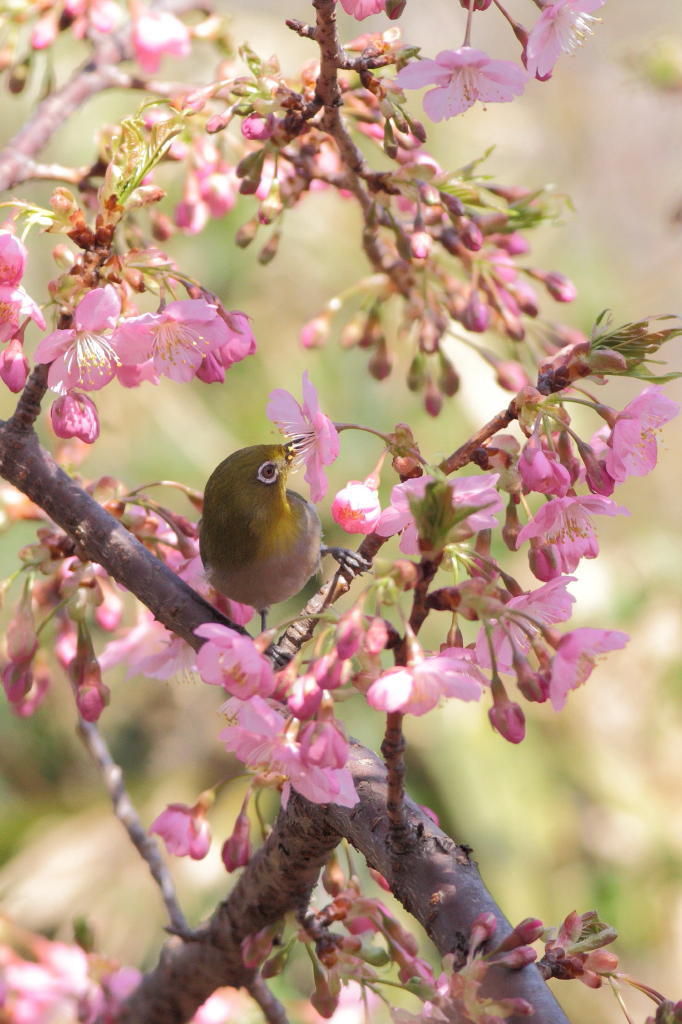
[114,299,236,381]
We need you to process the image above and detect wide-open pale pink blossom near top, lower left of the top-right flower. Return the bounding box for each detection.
[395,46,527,121]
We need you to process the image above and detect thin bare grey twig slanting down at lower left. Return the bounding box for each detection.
[78,717,191,936]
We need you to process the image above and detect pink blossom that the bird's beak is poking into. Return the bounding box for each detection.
[266,370,339,502]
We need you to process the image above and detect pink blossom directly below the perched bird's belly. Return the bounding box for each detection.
[195,623,274,700]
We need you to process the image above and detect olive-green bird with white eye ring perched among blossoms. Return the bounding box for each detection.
[199,438,370,631]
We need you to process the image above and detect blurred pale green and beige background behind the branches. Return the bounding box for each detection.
[0,0,682,1024]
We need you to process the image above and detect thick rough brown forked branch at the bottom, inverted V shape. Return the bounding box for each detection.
[122,743,568,1024]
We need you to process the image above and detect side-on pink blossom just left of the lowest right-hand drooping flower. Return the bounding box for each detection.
[475,577,576,672]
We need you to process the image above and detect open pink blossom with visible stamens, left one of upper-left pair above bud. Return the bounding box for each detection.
[35,285,121,394]
